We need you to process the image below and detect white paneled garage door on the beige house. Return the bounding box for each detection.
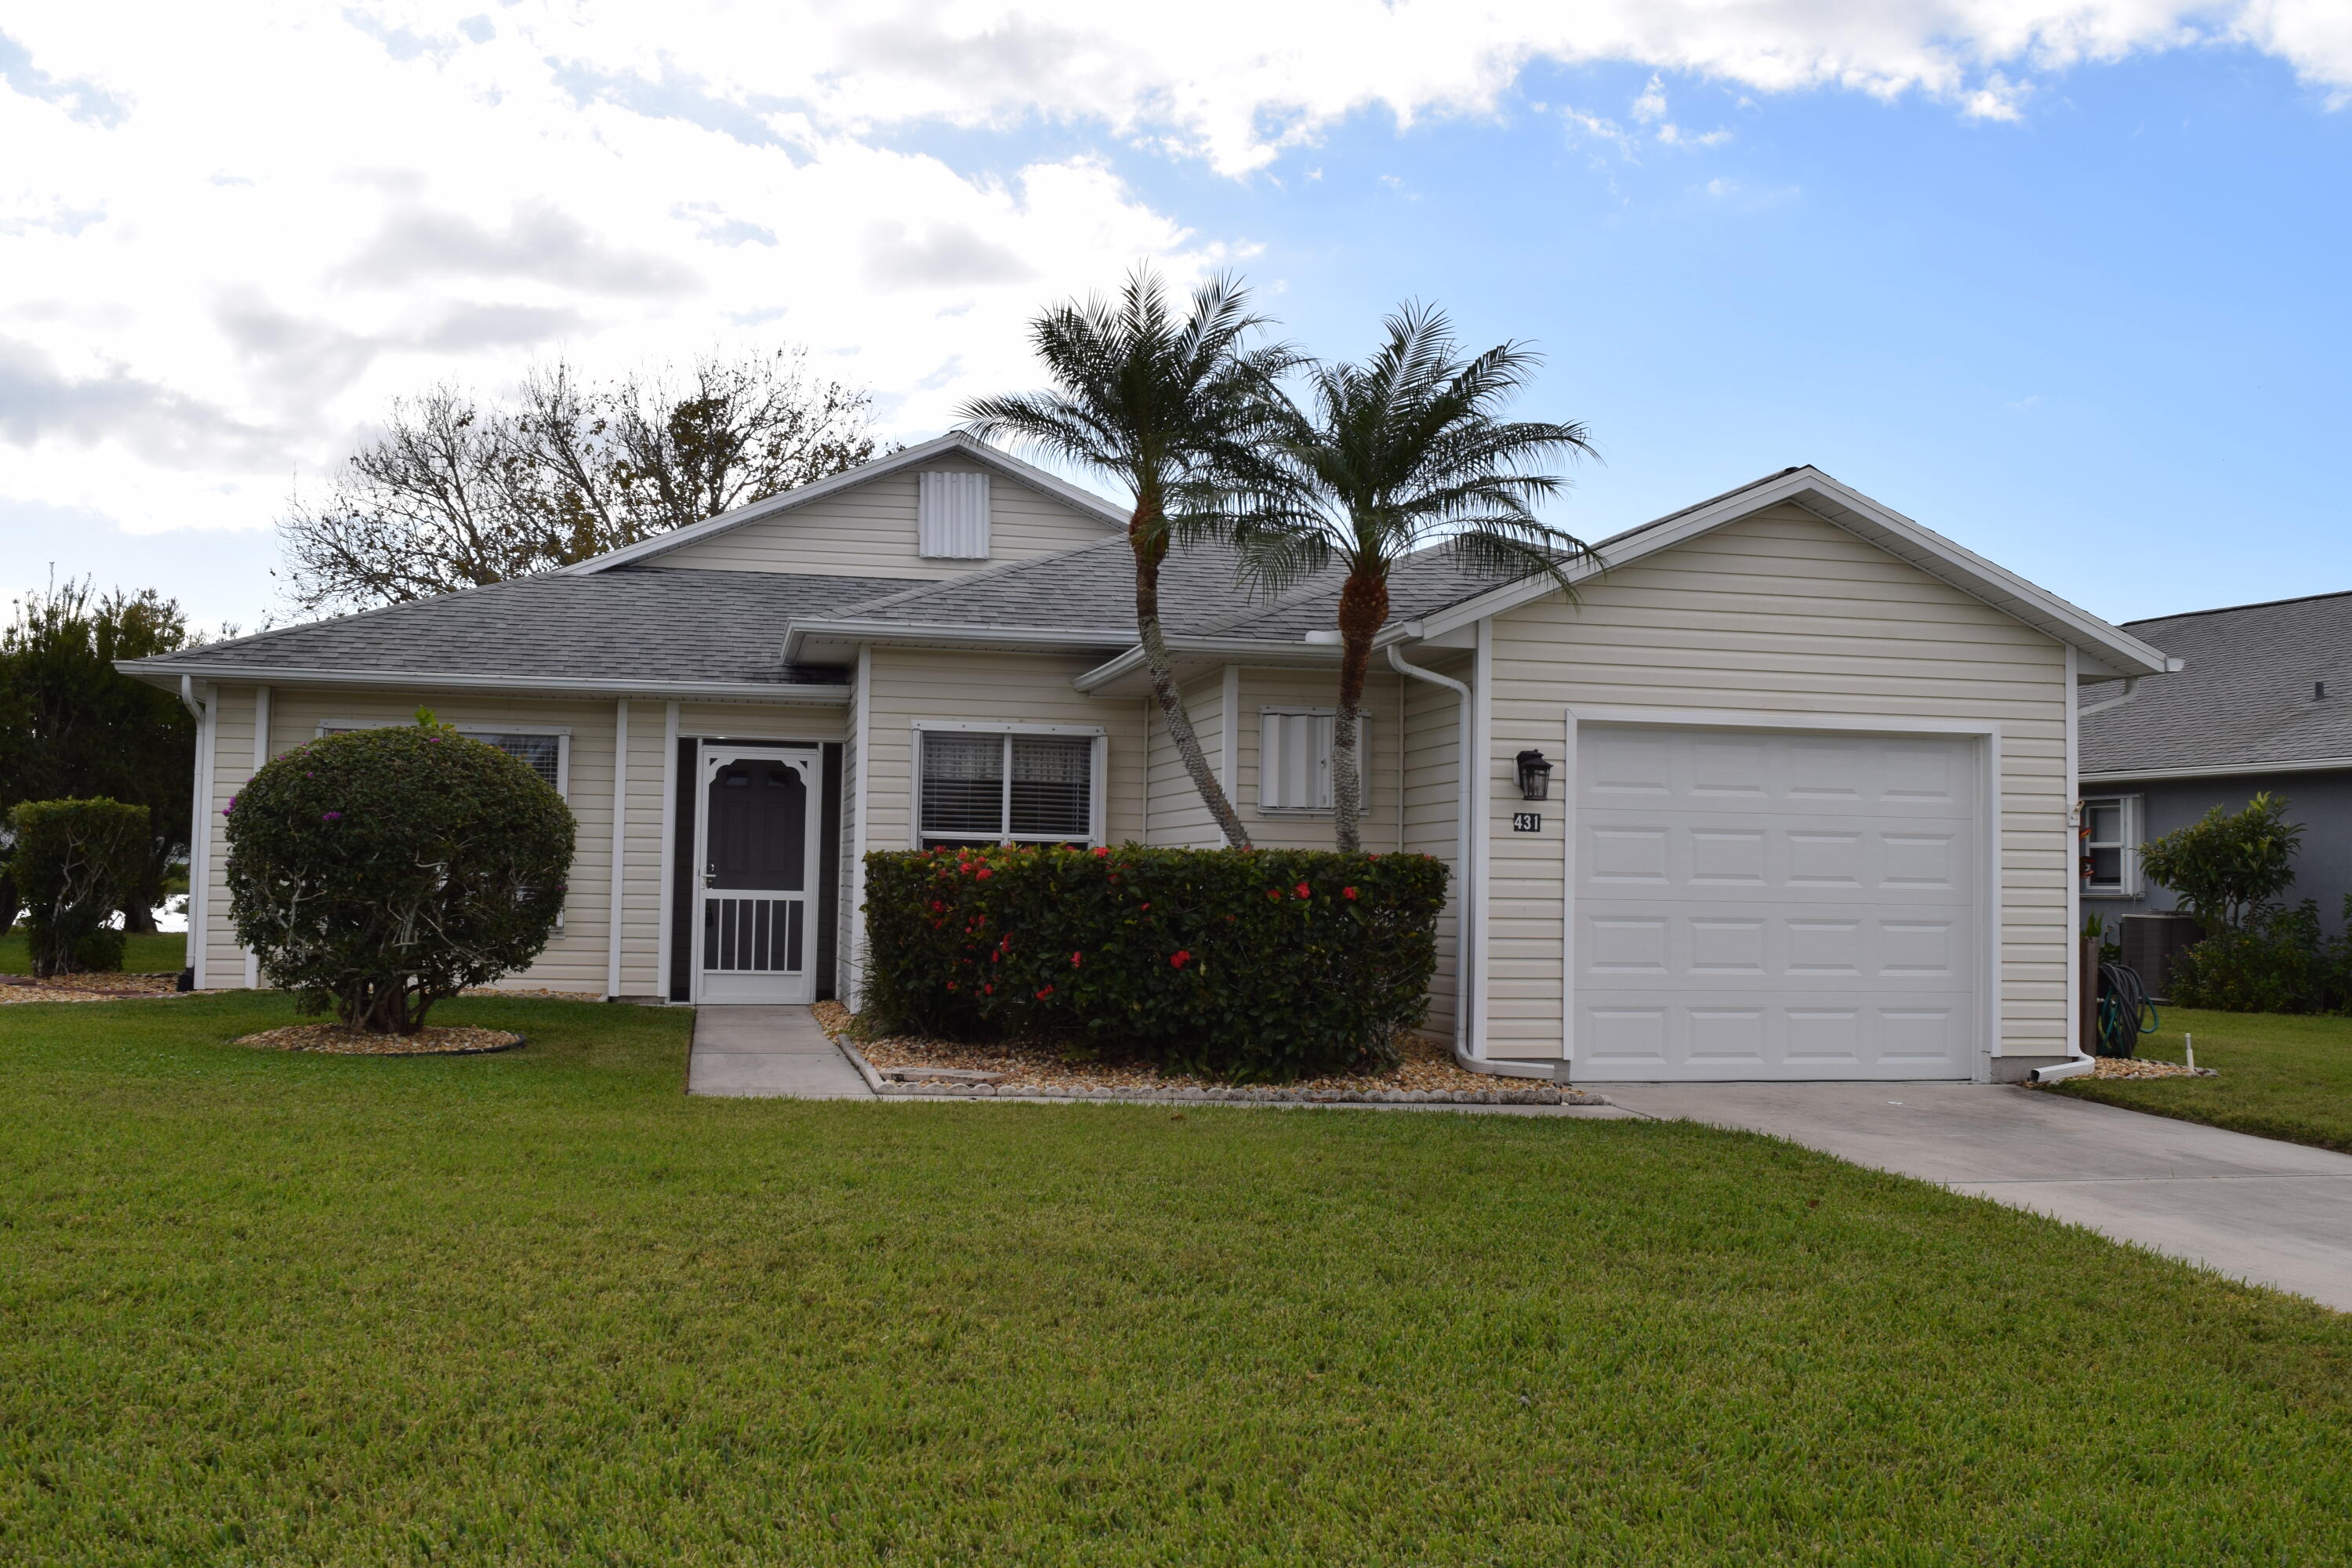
[1569,724,1985,1081]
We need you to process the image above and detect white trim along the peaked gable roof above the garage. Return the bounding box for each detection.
[1406,468,2180,675]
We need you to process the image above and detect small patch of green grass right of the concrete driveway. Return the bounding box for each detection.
[2056,1008,2352,1154]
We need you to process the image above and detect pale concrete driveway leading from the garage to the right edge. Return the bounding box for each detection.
[1606,1083,2352,1312]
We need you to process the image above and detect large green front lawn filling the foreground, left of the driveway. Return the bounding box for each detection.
[0,996,2352,1563]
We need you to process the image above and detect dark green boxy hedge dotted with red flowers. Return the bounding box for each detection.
[866,844,1446,1081]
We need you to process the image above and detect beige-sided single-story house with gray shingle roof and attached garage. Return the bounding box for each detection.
[127,437,2164,1079]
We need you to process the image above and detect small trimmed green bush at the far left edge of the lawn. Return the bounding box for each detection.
[9,799,148,975]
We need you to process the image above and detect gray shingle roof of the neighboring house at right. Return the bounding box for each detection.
[2082,593,2352,776]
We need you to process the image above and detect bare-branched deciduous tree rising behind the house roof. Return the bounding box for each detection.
[278,350,880,612]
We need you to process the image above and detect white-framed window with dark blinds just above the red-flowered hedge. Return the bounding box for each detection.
[915,729,1098,848]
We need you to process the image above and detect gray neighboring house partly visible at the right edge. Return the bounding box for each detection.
[2082,593,2352,928]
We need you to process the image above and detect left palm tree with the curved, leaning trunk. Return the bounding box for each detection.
[962,276,1296,848]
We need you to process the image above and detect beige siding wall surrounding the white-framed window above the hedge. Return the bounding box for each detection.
[866,649,1143,848]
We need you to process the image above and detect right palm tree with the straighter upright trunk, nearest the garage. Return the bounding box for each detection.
[1235,303,1599,851]
